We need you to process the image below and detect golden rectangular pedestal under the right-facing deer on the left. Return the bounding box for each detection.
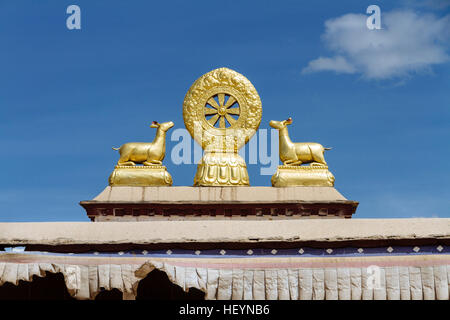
[109,166,172,187]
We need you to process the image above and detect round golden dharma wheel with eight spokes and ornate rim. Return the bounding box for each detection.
[183,68,262,152]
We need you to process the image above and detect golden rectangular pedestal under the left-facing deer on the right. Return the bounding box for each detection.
[271,166,335,187]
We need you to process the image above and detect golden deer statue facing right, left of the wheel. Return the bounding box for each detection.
[113,121,174,166]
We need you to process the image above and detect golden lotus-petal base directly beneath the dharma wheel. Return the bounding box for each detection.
[194,152,250,187]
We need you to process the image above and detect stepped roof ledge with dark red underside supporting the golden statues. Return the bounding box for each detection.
[80,187,358,221]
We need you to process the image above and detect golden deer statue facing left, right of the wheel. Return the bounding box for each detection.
[269,117,331,166]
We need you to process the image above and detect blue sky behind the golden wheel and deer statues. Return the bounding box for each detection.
[0,0,450,221]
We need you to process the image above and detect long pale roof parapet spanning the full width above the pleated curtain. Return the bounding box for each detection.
[0,218,450,246]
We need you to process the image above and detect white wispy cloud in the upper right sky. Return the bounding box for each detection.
[302,10,450,79]
